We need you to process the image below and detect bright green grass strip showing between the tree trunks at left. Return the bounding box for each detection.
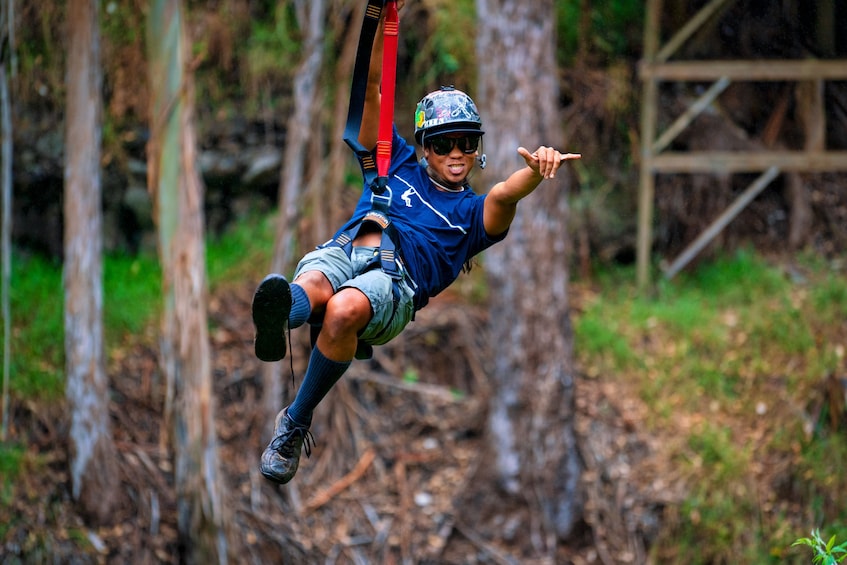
[0,210,274,401]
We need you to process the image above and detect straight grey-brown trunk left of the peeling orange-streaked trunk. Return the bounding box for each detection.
[63,0,118,523]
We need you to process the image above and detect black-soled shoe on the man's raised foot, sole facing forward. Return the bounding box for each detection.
[253,274,291,363]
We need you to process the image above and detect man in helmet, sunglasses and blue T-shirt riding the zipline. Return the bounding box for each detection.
[252,0,580,484]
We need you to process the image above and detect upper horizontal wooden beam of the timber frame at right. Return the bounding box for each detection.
[638,59,847,81]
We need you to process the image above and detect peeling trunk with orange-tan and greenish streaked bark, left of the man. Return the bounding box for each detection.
[148,0,227,564]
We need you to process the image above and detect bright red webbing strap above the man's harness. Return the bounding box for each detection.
[376,0,400,177]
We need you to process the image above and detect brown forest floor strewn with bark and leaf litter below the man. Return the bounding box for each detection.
[0,274,680,564]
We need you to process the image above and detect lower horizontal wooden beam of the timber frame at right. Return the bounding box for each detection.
[647,151,847,173]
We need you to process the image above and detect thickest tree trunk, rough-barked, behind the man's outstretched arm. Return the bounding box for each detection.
[476,0,581,554]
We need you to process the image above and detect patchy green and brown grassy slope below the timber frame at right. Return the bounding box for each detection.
[573,250,847,564]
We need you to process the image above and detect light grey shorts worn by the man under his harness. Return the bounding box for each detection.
[294,247,415,345]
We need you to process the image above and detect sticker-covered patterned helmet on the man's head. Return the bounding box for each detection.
[415,86,485,145]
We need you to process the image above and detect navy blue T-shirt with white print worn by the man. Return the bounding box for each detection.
[335,128,506,309]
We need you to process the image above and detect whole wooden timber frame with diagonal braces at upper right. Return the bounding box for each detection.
[636,0,847,289]
